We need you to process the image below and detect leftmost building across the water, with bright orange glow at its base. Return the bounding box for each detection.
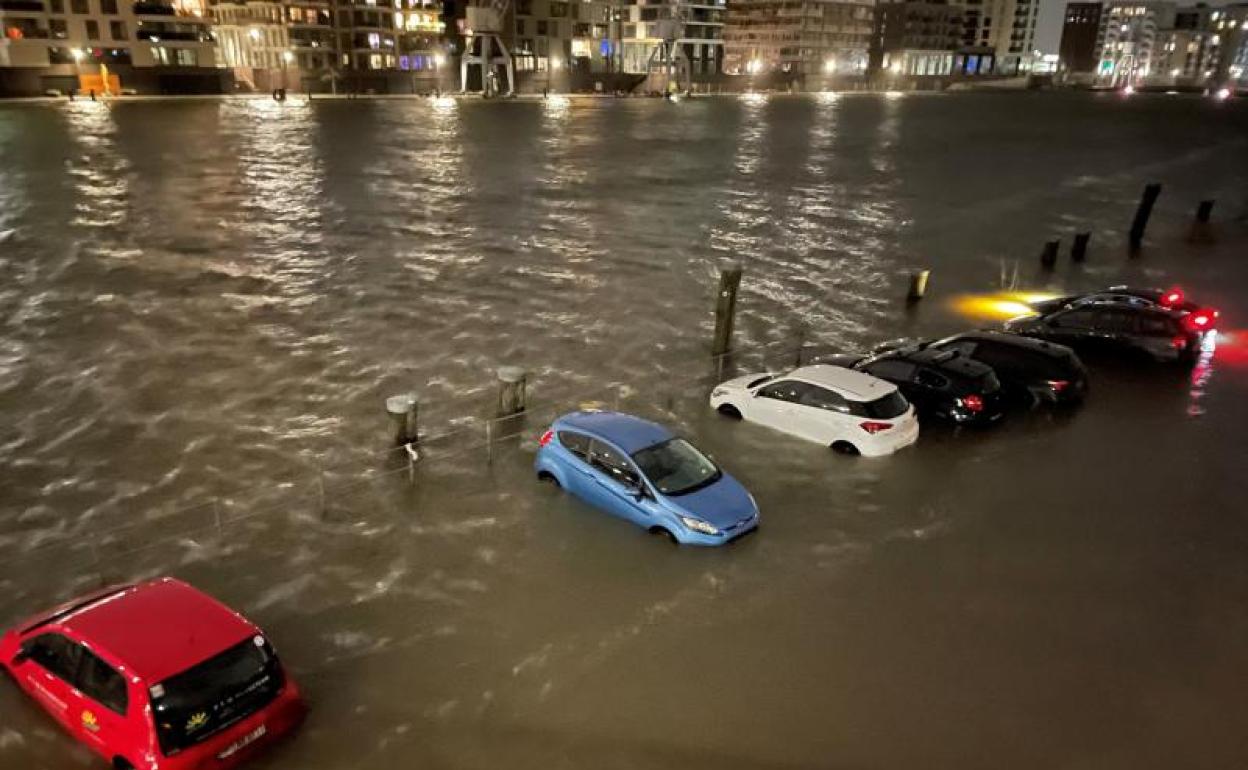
[0,0,222,95]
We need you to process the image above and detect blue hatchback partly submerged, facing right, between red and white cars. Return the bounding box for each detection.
[534,412,759,545]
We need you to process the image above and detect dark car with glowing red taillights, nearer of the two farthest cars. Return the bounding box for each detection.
[1006,301,1208,363]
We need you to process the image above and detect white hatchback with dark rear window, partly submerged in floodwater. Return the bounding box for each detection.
[710,364,919,457]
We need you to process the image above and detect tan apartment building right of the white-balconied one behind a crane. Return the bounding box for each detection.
[724,0,875,81]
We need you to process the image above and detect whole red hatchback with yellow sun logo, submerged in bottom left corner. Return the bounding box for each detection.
[0,578,306,770]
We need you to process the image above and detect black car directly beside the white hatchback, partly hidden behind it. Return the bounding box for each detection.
[824,348,1005,424]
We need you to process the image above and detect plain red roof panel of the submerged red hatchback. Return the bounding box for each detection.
[59,578,260,685]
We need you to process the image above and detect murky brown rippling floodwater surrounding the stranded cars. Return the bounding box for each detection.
[0,94,1248,770]
